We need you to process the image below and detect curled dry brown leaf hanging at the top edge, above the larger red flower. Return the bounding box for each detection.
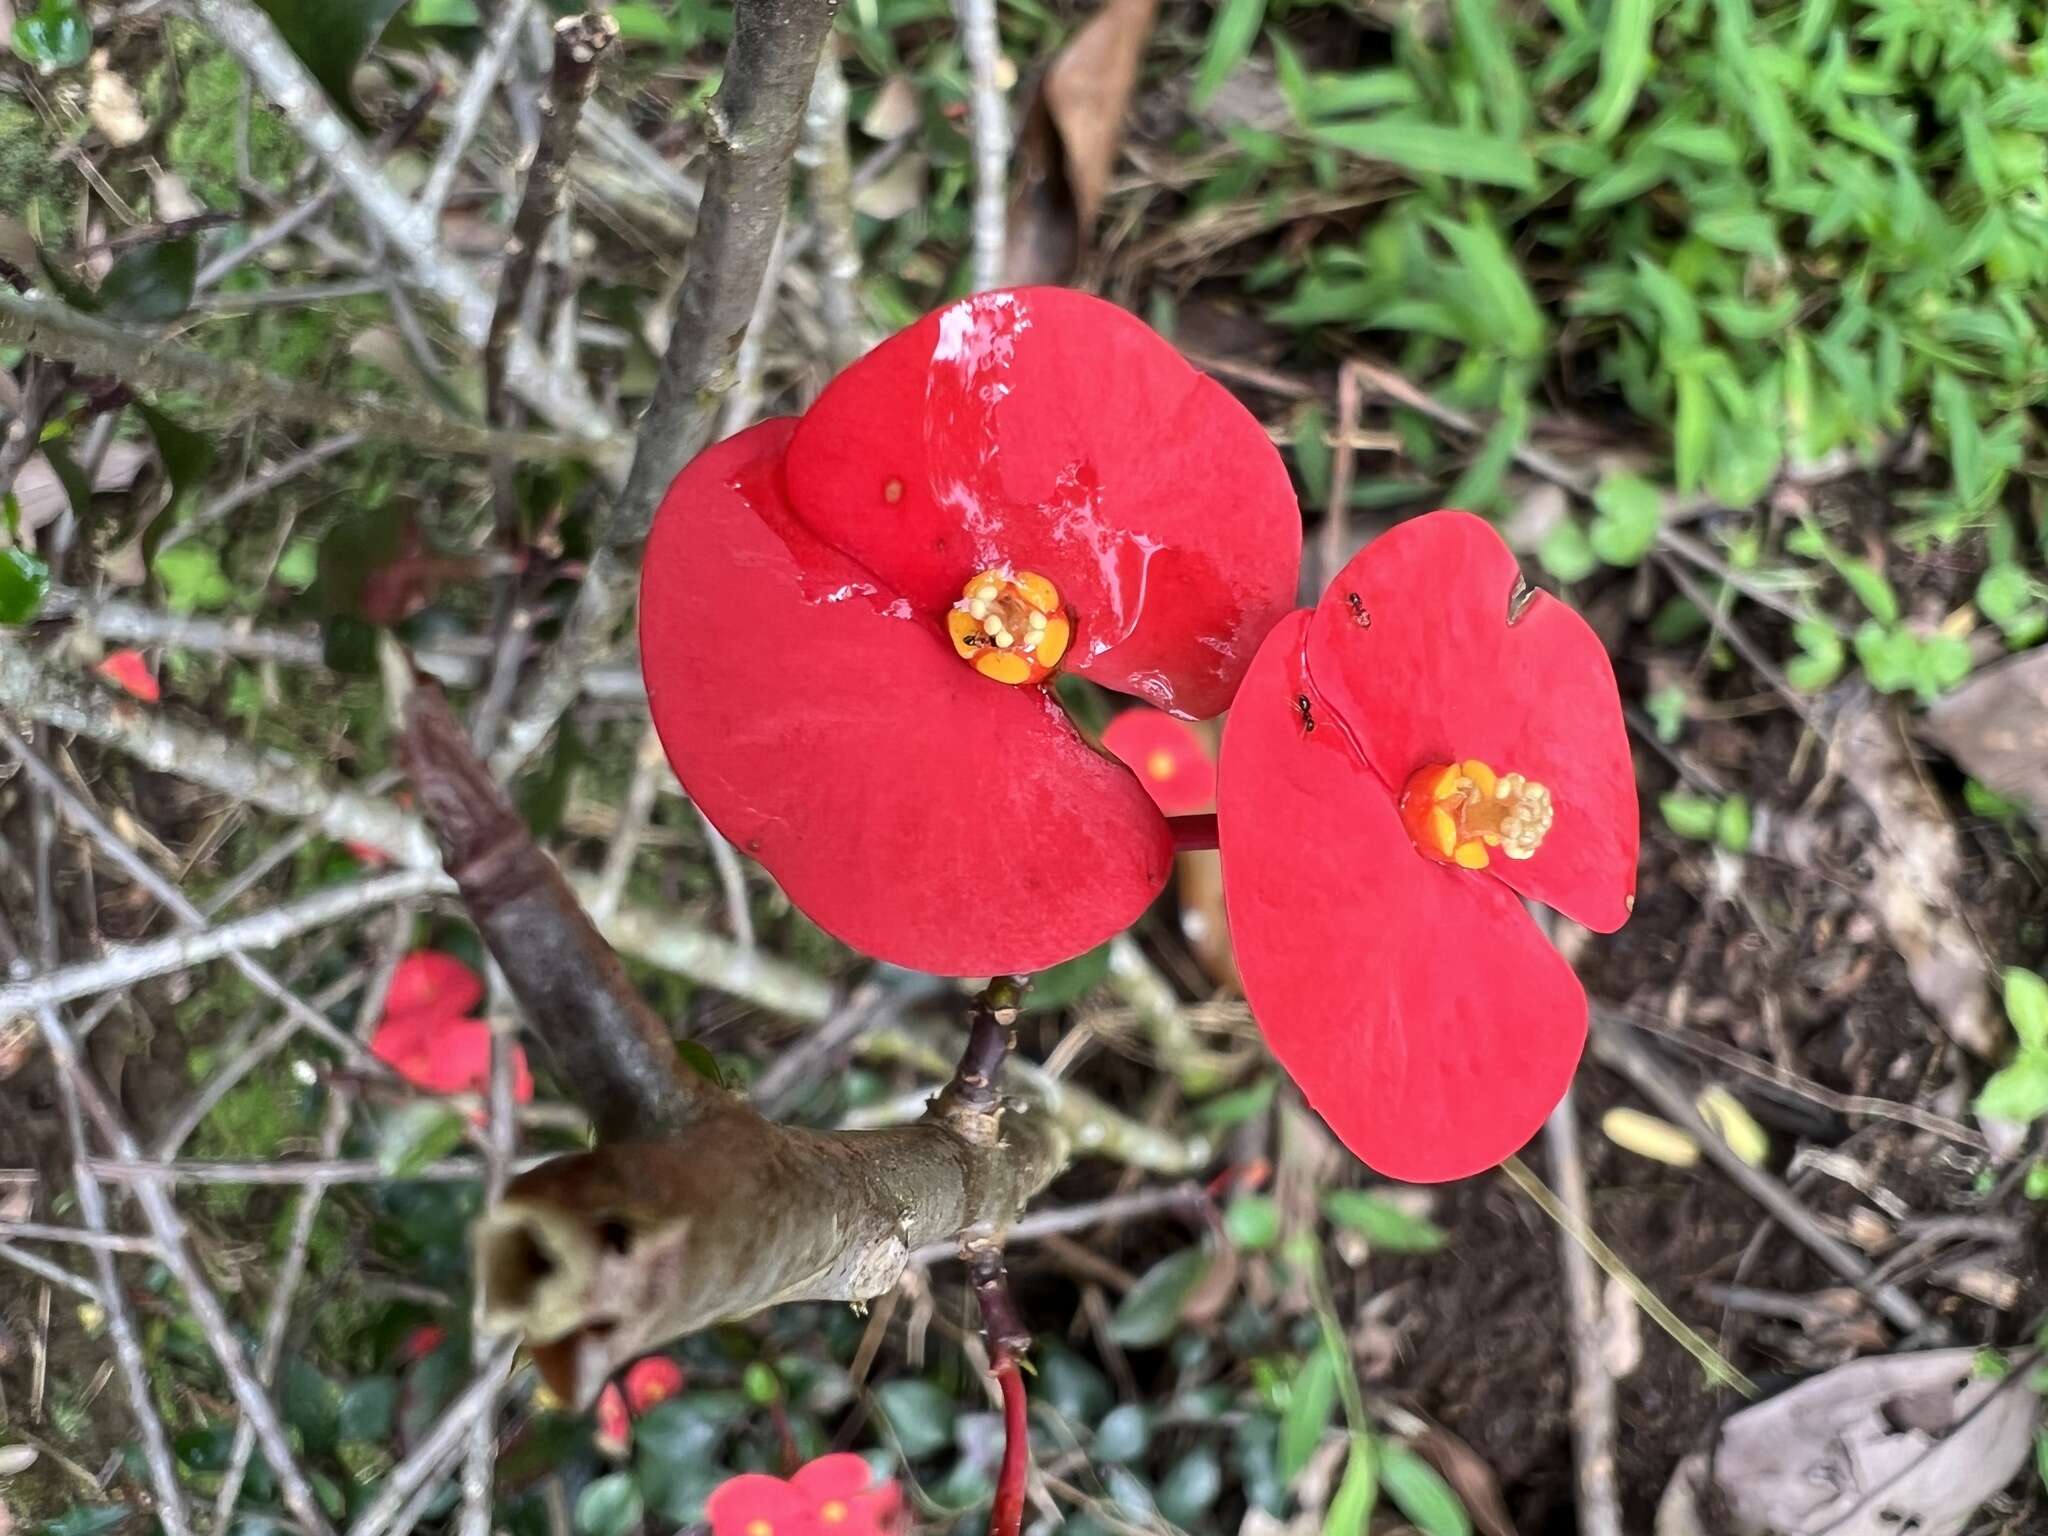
[1004,0,1159,283]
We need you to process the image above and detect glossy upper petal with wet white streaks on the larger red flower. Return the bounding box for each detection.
[788,289,1300,719]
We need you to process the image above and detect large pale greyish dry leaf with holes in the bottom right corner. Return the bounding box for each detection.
[1657,1350,2040,1536]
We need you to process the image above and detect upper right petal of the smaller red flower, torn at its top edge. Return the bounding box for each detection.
[1307,512,1640,934]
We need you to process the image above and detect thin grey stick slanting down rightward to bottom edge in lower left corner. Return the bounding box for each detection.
[25,1011,330,1536]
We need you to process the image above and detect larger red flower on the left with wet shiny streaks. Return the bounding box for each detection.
[641,289,1300,975]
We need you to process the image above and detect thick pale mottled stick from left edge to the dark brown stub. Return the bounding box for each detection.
[0,635,438,866]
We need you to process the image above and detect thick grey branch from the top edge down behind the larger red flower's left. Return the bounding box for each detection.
[487,0,838,780]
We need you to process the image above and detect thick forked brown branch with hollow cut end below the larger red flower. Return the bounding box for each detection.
[401,688,1067,1403]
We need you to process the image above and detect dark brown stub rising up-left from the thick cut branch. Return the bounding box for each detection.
[399,684,731,1141]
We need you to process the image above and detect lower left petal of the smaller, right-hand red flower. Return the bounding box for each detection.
[1219,612,1585,1182]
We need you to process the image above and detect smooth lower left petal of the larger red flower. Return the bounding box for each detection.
[641,420,1171,975]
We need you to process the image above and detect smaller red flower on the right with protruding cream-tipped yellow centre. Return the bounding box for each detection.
[1219,512,1638,1180]
